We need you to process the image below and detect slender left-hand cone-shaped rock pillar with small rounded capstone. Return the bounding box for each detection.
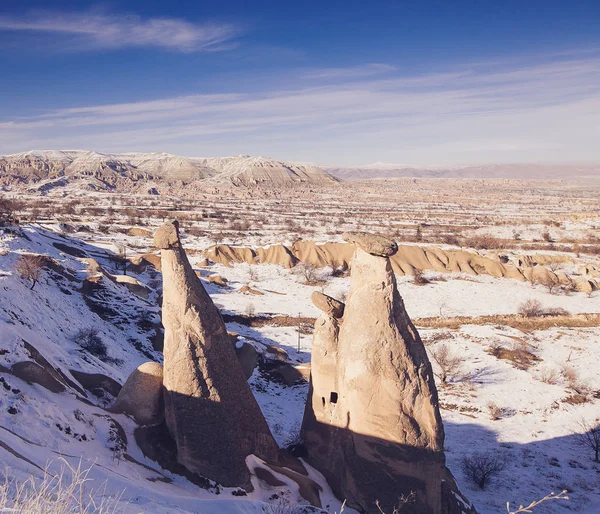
[154,222,279,487]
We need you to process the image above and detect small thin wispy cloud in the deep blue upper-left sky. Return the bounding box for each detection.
[0,12,240,52]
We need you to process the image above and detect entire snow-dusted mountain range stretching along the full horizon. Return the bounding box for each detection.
[0,150,600,192]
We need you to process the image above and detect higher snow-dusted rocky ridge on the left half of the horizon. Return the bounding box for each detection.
[0,150,337,190]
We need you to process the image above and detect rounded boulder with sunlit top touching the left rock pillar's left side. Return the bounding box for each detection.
[111,362,164,425]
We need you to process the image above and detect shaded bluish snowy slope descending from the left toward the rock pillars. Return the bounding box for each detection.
[0,226,348,514]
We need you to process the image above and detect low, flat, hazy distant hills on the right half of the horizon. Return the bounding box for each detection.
[324,163,600,180]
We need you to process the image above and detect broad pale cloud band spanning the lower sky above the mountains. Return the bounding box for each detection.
[0,57,600,164]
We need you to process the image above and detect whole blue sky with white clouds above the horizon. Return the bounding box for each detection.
[0,0,600,166]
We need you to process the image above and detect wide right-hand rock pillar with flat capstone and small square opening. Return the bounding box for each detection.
[302,236,470,514]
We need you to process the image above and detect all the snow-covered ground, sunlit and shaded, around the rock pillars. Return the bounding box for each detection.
[0,226,600,514]
